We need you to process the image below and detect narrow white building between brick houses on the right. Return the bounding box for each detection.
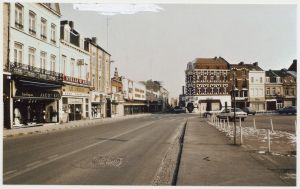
[249,70,266,111]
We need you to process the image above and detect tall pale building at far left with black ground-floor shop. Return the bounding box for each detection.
[4,3,62,128]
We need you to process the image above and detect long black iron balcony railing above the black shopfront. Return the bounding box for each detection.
[10,62,63,82]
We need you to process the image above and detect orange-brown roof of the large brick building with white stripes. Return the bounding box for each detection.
[193,57,230,69]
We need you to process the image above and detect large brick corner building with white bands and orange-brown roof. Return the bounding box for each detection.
[185,57,231,113]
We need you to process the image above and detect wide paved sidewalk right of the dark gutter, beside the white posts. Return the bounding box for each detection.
[177,117,296,186]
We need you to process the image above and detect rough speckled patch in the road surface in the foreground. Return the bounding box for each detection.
[75,155,123,169]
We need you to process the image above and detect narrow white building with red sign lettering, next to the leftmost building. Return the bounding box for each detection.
[60,20,91,122]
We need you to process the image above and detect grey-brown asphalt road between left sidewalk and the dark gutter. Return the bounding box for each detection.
[3,114,193,185]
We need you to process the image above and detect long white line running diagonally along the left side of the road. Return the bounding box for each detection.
[3,121,154,181]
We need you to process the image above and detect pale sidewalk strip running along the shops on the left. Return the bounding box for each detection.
[3,113,151,138]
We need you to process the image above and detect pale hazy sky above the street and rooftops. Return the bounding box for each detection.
[60,3,297,97]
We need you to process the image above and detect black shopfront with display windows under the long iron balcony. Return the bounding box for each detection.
[12,80,61,127]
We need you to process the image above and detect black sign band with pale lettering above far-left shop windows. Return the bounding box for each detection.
[15,90,60,99]
